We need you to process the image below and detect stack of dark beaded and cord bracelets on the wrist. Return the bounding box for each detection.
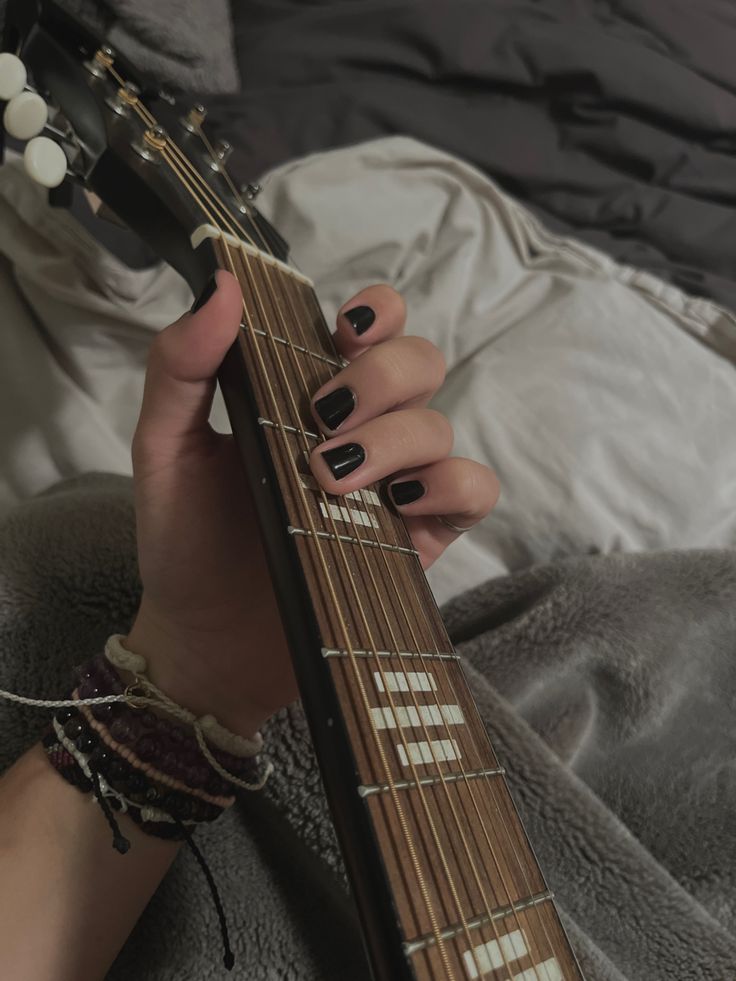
[43,635,270,850]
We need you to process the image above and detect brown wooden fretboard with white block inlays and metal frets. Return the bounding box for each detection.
[204,230,582,981]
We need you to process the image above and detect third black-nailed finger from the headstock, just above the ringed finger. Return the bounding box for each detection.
[309,409,453,494]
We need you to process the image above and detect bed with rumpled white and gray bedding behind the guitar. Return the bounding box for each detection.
[0,0,736,981]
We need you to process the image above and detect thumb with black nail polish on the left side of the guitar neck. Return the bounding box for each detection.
[134,270,243,454]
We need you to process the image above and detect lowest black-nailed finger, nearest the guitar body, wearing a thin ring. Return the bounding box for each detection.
[388,457,500,535]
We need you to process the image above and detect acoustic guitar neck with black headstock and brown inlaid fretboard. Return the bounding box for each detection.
[0,0,583,981]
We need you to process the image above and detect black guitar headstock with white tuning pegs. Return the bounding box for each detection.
[0,0,287,290]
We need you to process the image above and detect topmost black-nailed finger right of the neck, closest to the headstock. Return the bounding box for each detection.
[333,285,406,361]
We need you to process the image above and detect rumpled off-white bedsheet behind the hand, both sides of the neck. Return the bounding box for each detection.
[0,137,736,602]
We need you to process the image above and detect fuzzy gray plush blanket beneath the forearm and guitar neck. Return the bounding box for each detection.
[0,474,736,981]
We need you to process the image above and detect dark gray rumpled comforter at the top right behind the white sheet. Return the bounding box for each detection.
[201,0,736,309]
